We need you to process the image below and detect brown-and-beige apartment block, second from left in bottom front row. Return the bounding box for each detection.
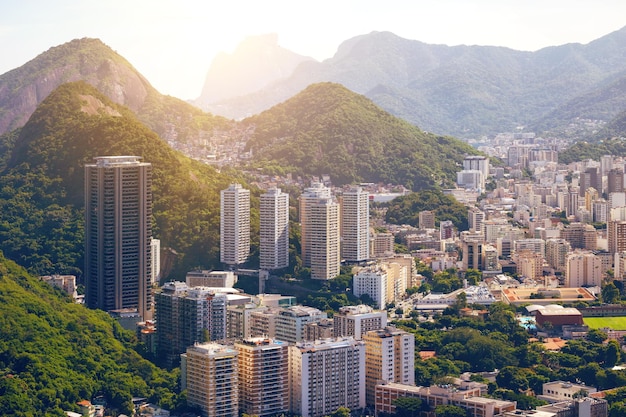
[235,338,289,417]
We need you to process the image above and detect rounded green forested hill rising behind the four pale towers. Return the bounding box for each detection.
[242,83,477,190]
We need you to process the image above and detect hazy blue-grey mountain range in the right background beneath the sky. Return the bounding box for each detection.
[201,28,626,137]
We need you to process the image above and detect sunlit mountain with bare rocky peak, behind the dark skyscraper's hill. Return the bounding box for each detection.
[0,38,230,142]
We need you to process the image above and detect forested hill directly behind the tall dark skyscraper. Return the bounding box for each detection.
[0,82,249,276]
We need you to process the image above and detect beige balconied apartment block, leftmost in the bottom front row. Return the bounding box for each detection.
[180,343,239,417]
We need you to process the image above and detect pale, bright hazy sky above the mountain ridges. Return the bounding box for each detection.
[0,0,626,99]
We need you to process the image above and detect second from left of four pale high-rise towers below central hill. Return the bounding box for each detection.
[259,187,289,270]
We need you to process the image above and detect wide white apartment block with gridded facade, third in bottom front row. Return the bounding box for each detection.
[289,338,365,417]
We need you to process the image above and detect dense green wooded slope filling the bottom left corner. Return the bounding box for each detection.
[0,253,179,417]
